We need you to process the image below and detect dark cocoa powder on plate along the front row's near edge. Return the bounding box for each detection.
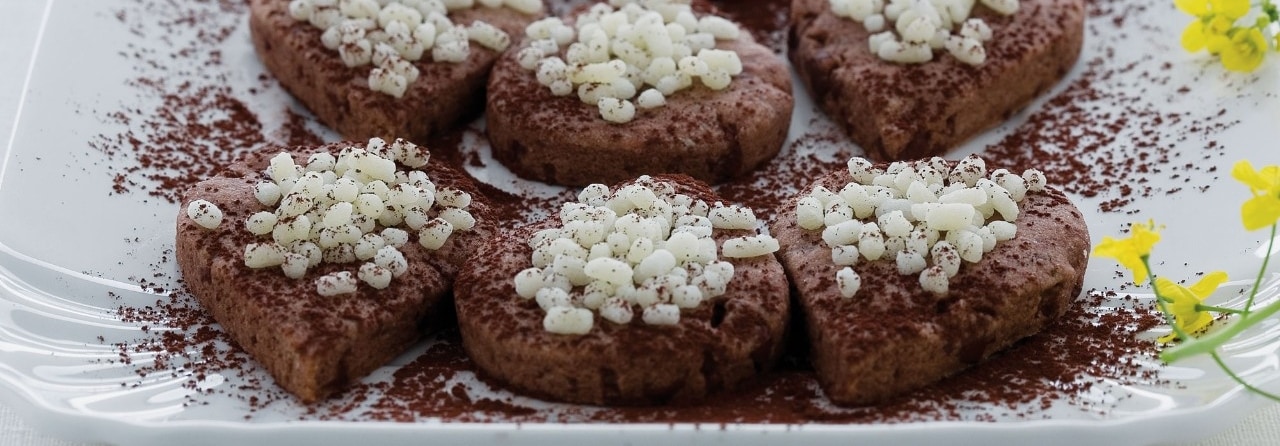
[338,293,1161,423]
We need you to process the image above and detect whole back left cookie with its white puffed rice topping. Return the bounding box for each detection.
[248,0,543,142]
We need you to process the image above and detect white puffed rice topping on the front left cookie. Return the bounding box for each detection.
[225,138,476,296]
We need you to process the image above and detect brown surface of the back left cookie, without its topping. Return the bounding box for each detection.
[248,0,539,142]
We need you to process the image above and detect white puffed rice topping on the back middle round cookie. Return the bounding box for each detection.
[516,0,742,123]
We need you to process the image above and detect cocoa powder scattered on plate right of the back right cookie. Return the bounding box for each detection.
[983,0,1236,213]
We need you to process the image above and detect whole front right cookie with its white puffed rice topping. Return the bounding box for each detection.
[772,158,1089,405]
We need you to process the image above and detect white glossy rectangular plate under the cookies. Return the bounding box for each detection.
[0,0,1280,445]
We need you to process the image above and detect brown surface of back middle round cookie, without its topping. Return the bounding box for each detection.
[485,6,794,186]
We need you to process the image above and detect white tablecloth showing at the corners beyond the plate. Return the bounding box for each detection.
[0,0,1280,445]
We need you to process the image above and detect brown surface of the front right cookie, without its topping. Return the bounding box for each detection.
[771,162,1089,405]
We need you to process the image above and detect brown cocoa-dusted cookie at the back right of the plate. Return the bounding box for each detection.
[788,0,1084,160]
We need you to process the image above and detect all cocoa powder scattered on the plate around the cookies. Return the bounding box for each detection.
[90,0,1233,423]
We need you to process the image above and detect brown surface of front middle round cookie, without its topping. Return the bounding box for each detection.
[456,176,790,405]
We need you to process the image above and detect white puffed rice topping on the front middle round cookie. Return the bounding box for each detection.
[513,177,778,335]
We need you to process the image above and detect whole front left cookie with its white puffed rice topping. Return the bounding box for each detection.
[177,140,494,402]
